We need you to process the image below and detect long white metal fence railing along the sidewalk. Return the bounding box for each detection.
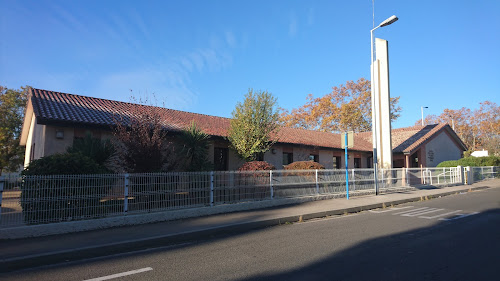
[0,167,499,228]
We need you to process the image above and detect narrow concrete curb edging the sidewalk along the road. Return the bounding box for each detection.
[0,183,489,273]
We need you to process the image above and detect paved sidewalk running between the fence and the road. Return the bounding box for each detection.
[0,179,500,273]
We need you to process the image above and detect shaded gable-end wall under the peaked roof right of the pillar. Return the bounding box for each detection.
[422,131,463,167]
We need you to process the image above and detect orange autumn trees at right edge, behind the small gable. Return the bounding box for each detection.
[415,101,500,155]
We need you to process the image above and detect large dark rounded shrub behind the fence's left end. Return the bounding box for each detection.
[21,153,113,224]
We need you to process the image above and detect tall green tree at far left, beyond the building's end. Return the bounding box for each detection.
[0,86,28,175]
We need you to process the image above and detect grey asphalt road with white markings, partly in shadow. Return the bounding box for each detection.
[0,185,500,281]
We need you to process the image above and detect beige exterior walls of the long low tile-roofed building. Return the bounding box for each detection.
[24,120,463,170]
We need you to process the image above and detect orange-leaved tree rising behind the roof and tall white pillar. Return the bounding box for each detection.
[281,78,401,133]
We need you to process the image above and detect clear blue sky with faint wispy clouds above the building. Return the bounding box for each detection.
[0,0,500,128]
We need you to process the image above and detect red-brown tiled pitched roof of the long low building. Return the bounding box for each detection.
[26,88,464,152]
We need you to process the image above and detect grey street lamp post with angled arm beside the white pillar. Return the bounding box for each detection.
[370,15,398,195]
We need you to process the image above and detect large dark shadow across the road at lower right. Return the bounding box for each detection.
[239,209,500,281]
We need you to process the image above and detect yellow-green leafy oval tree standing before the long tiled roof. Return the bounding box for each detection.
[228,89,279,161]
